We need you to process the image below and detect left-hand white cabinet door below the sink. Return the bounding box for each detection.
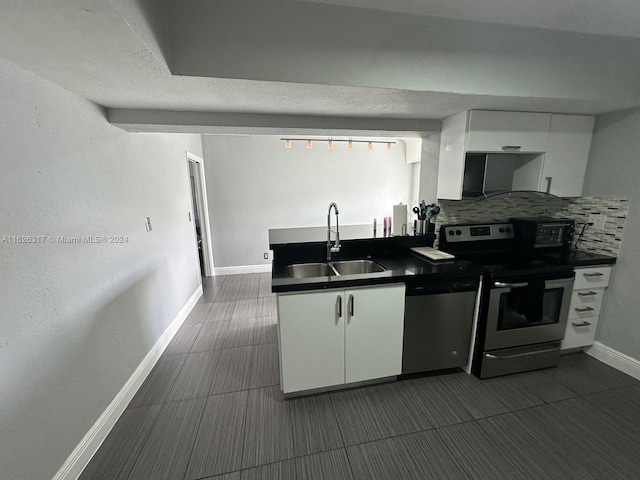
[278,291,345,393]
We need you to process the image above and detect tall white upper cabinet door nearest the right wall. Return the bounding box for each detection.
[540,115,595,197]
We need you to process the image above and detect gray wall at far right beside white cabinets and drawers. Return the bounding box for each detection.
[583,109,640,360]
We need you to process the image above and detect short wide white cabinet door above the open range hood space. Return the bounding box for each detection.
[467,110,551,153]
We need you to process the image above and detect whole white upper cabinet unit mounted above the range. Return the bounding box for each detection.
[437,110,595,200]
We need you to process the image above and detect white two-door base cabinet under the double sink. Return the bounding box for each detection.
[278,284,405,393]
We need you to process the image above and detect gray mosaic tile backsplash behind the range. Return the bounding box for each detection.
[436,195,629,256]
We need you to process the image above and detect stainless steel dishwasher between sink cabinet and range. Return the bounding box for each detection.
[402,278,479,374]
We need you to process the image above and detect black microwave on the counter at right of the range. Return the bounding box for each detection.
[509,217,575,250]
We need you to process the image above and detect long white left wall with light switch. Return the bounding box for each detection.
[0,60,201,480]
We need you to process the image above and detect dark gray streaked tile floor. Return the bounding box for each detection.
[81,274,640,480]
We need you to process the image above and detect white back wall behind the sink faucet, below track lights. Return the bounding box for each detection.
[202,135,414,268]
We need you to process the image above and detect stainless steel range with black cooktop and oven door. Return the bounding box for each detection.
[439,222,574,378]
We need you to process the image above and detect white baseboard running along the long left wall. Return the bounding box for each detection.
[53,285,202,480]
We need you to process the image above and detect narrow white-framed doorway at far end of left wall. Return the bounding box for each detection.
[187,152,215,277]
